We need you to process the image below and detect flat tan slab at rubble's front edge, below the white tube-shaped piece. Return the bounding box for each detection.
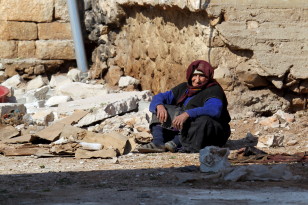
[75,149,117,159]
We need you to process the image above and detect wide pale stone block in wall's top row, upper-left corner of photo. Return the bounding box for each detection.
[2,0,54,22]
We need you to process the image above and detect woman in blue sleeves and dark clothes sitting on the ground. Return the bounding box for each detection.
[138,60,231,153]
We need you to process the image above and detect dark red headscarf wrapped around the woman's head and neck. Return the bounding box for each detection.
[177,60,219,104]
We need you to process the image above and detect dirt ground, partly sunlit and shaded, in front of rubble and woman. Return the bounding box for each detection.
[0,112,308,205]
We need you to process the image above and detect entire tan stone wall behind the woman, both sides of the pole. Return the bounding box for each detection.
[0,0,308,115]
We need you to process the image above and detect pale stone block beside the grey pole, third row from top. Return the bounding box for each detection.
[35,40,75,60]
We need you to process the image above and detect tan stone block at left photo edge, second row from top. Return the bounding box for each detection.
[0,21,37,40]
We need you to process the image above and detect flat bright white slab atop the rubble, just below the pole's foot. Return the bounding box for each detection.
[56,82,108,100]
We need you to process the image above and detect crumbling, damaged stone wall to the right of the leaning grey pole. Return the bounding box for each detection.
[85,0,308,115]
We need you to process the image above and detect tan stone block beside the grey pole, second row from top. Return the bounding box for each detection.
[38,22,72,40]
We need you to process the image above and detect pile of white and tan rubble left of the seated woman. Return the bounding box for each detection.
[0,69,152,158]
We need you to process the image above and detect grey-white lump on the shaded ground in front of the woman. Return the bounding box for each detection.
[199,146,230,172]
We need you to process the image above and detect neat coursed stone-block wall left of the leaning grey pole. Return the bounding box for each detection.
[0,0,75,80]
